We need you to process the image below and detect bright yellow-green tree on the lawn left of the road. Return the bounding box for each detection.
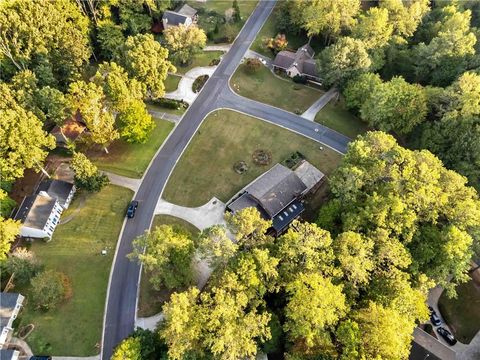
[117,100,155,143]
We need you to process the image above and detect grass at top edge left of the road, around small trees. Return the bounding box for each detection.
[188,0,258,44]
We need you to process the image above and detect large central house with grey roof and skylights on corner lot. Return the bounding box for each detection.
[227,160,324,234]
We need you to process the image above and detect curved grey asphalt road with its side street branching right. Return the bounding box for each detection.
[101,1,350,360]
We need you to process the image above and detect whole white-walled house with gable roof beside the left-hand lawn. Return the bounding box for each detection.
[14,191,63,240]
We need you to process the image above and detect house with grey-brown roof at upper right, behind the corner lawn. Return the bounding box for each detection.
[273,44,320,81]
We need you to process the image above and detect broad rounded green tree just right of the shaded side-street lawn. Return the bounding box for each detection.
[360,77,427,135]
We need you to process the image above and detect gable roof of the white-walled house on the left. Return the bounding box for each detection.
[15,194,57,230]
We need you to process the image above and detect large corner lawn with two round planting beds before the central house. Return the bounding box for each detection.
[163,110,341,207]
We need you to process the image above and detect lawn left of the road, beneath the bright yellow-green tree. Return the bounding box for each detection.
[94,119,174,178]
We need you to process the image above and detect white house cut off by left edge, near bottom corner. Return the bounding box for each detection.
[0,292,24,348]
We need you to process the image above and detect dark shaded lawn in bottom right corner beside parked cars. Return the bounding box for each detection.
[438,280,480,344]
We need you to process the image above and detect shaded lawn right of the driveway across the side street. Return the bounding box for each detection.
[315,99,368,138]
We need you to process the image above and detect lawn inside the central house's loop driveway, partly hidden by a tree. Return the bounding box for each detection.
[137,215,200,317]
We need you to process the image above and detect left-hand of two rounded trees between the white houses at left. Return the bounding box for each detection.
[6,248,40,285]
